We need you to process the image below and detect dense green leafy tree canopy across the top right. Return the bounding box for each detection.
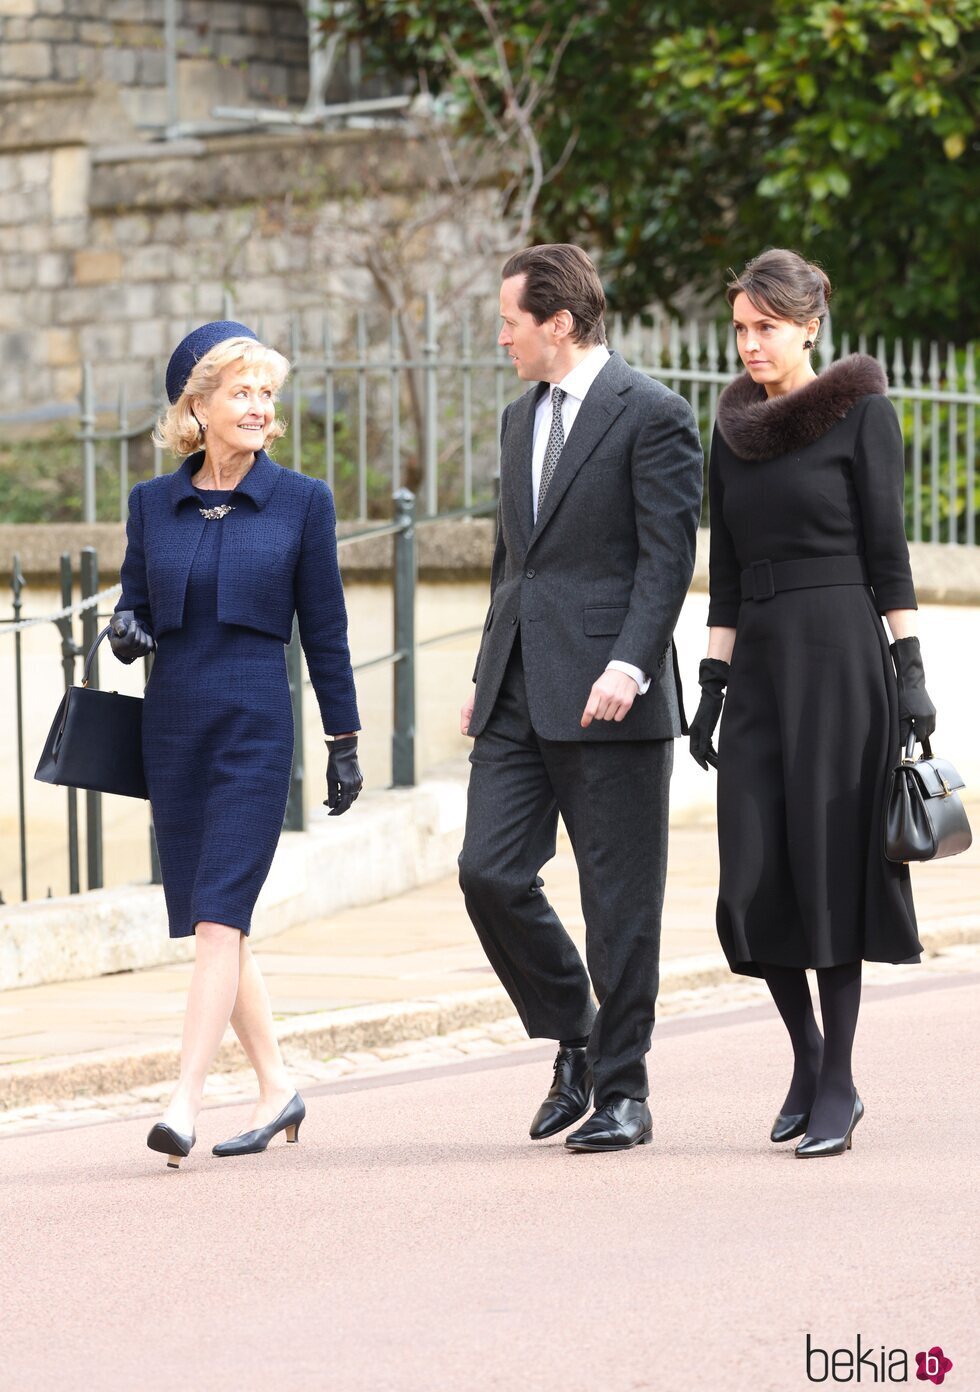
[327,0,980,341]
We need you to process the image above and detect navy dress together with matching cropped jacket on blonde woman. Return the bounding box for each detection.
[118,452,359,938]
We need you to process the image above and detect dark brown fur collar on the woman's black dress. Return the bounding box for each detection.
[718,354,888,459]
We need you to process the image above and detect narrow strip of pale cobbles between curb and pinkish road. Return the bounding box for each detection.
[0,944,980,1139]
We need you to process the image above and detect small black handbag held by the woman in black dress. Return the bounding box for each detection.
[885,734,973,863]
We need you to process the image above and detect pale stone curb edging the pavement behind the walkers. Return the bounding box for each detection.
[0,915,980,1111]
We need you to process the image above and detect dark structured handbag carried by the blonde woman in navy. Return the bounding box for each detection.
[35,625,148,798]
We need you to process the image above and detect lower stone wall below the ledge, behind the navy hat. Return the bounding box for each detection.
[0,123,451,412]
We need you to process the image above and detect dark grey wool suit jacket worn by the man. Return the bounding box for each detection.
[469,354,704,741]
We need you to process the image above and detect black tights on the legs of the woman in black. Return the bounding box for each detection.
[763,962,862,1137]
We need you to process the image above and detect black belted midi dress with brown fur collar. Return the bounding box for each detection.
[709,355,922,976]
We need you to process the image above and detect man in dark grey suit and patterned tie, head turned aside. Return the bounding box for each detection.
[459,245,703,1151]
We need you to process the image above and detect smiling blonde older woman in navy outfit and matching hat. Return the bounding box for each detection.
[110,322,362,1166]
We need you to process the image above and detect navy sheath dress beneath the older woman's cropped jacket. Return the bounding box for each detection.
[143,490,292,937]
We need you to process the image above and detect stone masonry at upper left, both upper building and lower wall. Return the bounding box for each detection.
[0,0,419,415]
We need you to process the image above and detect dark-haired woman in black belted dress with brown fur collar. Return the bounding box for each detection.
[690,249,935,1158]
